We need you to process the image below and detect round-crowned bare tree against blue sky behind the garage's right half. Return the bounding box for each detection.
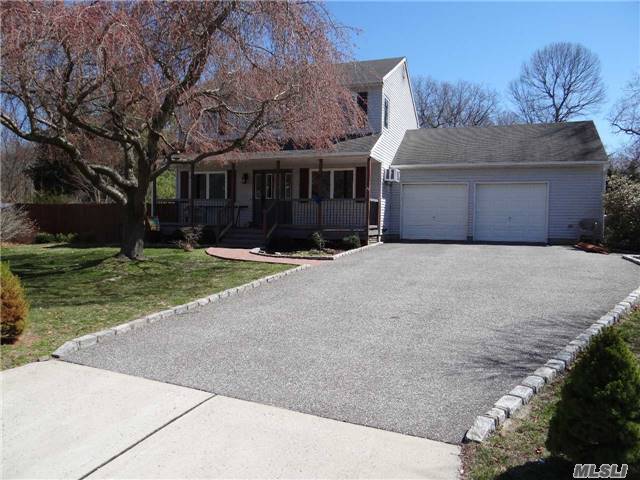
[509,42,605,123]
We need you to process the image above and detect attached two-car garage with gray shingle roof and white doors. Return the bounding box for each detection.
[384,122,608,243]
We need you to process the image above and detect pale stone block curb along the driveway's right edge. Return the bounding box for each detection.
[464,287,640,443]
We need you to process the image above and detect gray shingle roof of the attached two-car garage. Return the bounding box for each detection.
[393,121,607,166]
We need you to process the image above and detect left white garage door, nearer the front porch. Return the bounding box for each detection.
[402,184,469,240]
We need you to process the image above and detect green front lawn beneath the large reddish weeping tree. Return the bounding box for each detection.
[0,245,291,369]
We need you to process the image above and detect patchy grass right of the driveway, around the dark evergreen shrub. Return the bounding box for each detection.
[462,309,640,480]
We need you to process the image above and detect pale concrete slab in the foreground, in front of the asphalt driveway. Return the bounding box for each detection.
[0,361,459,480]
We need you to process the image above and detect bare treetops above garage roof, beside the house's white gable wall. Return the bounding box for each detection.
[413,77,498,128]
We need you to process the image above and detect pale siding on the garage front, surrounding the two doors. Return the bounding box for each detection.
[385,165,604,241]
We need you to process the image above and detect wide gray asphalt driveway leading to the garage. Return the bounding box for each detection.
[67,244,640,443]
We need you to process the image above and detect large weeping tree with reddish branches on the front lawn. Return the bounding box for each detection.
[0,0,359,258]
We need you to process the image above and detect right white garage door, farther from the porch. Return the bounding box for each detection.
[474,183,547,242]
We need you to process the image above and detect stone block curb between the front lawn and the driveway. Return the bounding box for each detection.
[51,265,310,358]
